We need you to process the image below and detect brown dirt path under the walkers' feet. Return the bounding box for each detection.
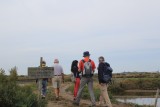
[47,83,132,107]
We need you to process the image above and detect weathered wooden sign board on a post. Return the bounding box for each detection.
[28,67,54,79]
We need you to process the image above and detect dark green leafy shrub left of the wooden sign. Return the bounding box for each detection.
[0,68,47,107]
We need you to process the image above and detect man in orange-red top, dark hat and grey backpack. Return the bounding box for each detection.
[73,51,96,107]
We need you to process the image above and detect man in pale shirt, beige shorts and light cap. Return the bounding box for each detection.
[52,59,64,100]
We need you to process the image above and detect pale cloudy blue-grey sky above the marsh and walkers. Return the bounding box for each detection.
[0,0,160,75]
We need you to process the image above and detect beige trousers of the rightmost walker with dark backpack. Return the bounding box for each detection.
[100,84,112,107]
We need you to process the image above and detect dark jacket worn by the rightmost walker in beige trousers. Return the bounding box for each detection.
[98,62,112,83]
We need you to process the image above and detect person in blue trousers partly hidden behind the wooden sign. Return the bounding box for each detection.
[41,61,48,99]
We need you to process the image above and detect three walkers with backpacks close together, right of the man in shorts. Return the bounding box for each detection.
[71,51,112,107]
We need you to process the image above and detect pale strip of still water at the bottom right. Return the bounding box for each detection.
[117,98,160,107]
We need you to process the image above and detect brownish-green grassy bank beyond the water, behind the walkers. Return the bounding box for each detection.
[65,73,160,95]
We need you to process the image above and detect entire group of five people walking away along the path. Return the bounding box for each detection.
[38,51,112,107]
